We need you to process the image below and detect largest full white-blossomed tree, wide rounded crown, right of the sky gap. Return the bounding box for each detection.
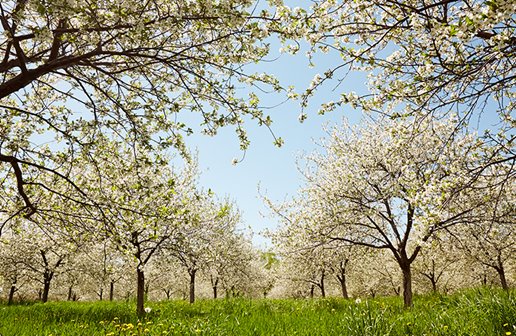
[268,120,498,306]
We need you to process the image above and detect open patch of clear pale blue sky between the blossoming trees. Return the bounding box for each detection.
[177,40,365,247]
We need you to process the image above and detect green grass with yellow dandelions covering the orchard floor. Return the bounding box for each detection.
[0,289,516,336]
